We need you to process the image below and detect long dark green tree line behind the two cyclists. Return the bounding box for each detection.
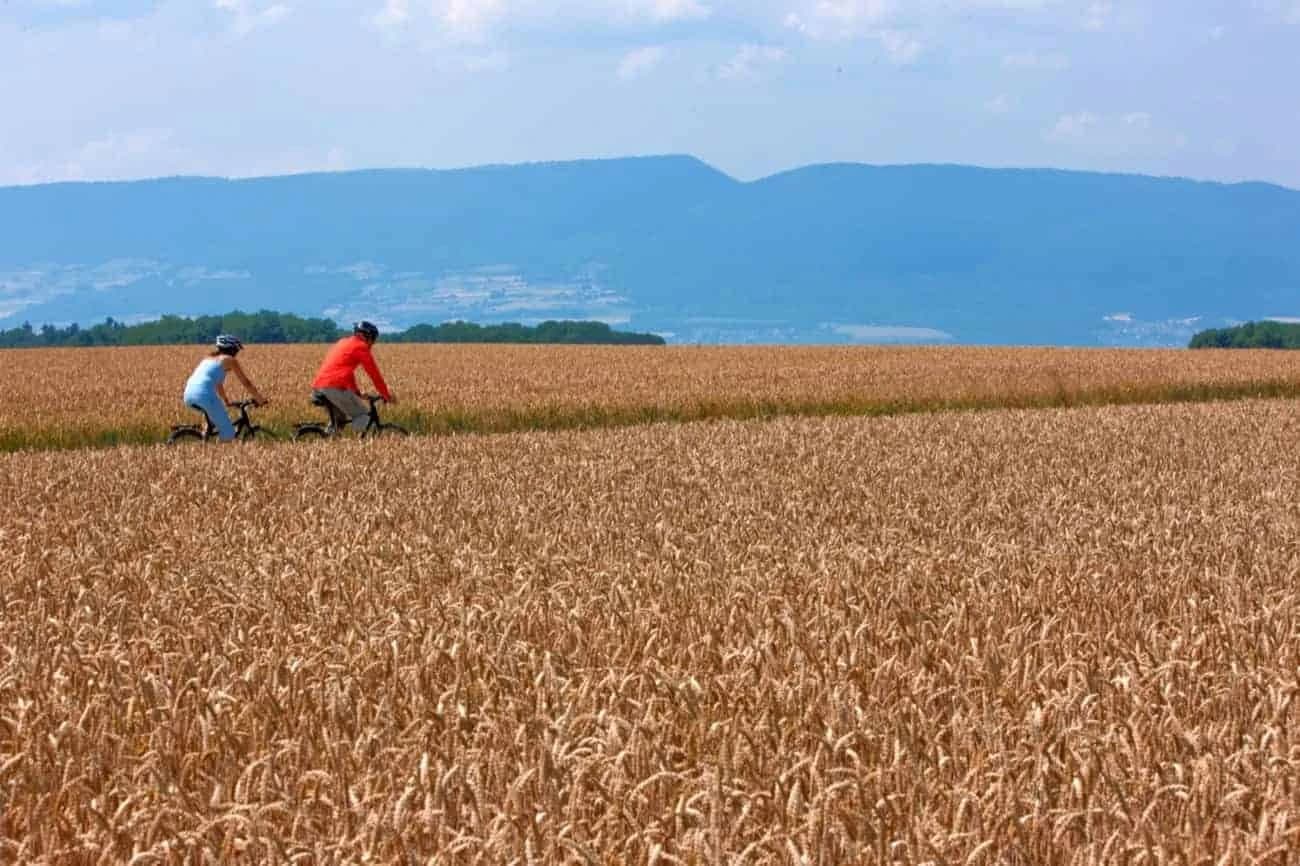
[0,309,664,348]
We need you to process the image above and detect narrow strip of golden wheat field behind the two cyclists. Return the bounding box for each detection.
[0,342,1300,451]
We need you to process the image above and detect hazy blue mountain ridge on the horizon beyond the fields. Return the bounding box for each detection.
[0,156,1300,345]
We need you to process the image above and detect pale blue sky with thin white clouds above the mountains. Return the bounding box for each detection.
[0,0,1300,189]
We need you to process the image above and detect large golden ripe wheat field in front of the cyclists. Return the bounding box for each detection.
[0,400,1300,865]
